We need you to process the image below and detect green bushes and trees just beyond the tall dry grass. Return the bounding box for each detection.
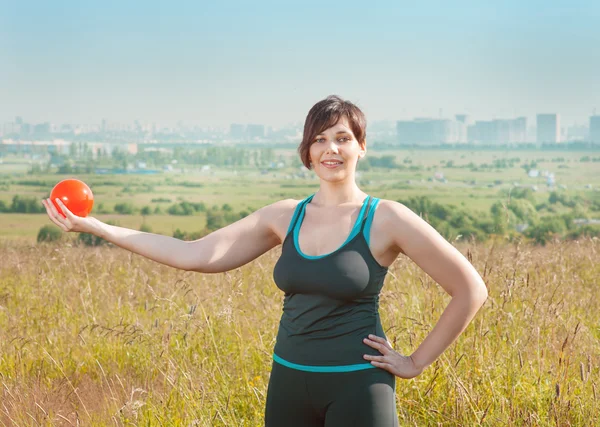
[36,188,600,245]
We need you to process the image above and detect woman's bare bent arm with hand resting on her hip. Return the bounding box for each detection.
[360,200,488,378]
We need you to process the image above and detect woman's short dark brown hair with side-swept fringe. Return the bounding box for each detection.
[298,95,367,169]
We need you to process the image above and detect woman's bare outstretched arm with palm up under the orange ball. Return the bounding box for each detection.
[43,199,297,273]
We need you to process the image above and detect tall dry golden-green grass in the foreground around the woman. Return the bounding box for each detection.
[0,240,600,426]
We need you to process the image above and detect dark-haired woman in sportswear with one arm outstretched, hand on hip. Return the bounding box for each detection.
[44,96,487,427]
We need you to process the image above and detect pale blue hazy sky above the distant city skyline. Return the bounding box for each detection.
[0,0,600,127]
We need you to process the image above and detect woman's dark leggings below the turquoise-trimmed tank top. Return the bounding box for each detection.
[265,362,398,427]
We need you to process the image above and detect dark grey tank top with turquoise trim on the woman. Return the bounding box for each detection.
[273,194,388,372]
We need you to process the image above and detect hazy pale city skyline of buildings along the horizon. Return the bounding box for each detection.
[0,113,600,145]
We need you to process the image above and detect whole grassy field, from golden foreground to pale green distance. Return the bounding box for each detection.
[0,150,600,426]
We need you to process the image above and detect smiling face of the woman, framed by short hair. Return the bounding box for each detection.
[309,116,366,182]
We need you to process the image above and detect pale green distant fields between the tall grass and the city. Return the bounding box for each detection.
[0,149,600,241]
